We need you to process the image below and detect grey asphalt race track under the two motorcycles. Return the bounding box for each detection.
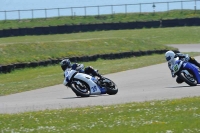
[0,44,200,113]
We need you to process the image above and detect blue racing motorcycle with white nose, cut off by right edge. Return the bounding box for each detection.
[172,60,200,86]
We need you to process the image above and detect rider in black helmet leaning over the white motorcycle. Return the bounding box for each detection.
[60,59,102,79]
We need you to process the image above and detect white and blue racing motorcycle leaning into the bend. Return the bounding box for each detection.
[63,68,118,97]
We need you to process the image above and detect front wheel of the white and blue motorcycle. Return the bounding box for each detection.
[70,79,90,97]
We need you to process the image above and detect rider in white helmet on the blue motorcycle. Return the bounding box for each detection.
[165,50,200,84]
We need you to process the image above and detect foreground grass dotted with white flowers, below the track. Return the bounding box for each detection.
[0,97,200,133]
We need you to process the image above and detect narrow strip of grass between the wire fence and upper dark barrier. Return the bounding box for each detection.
[0,10,200,29]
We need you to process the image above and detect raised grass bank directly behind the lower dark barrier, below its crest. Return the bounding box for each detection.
[0,38,171,64]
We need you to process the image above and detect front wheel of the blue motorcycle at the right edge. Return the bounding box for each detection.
[178,72,197,86]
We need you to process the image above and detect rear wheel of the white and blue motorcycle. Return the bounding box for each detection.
[103,78,118,95]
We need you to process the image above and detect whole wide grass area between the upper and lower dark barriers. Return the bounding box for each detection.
[0,26,200,64]
